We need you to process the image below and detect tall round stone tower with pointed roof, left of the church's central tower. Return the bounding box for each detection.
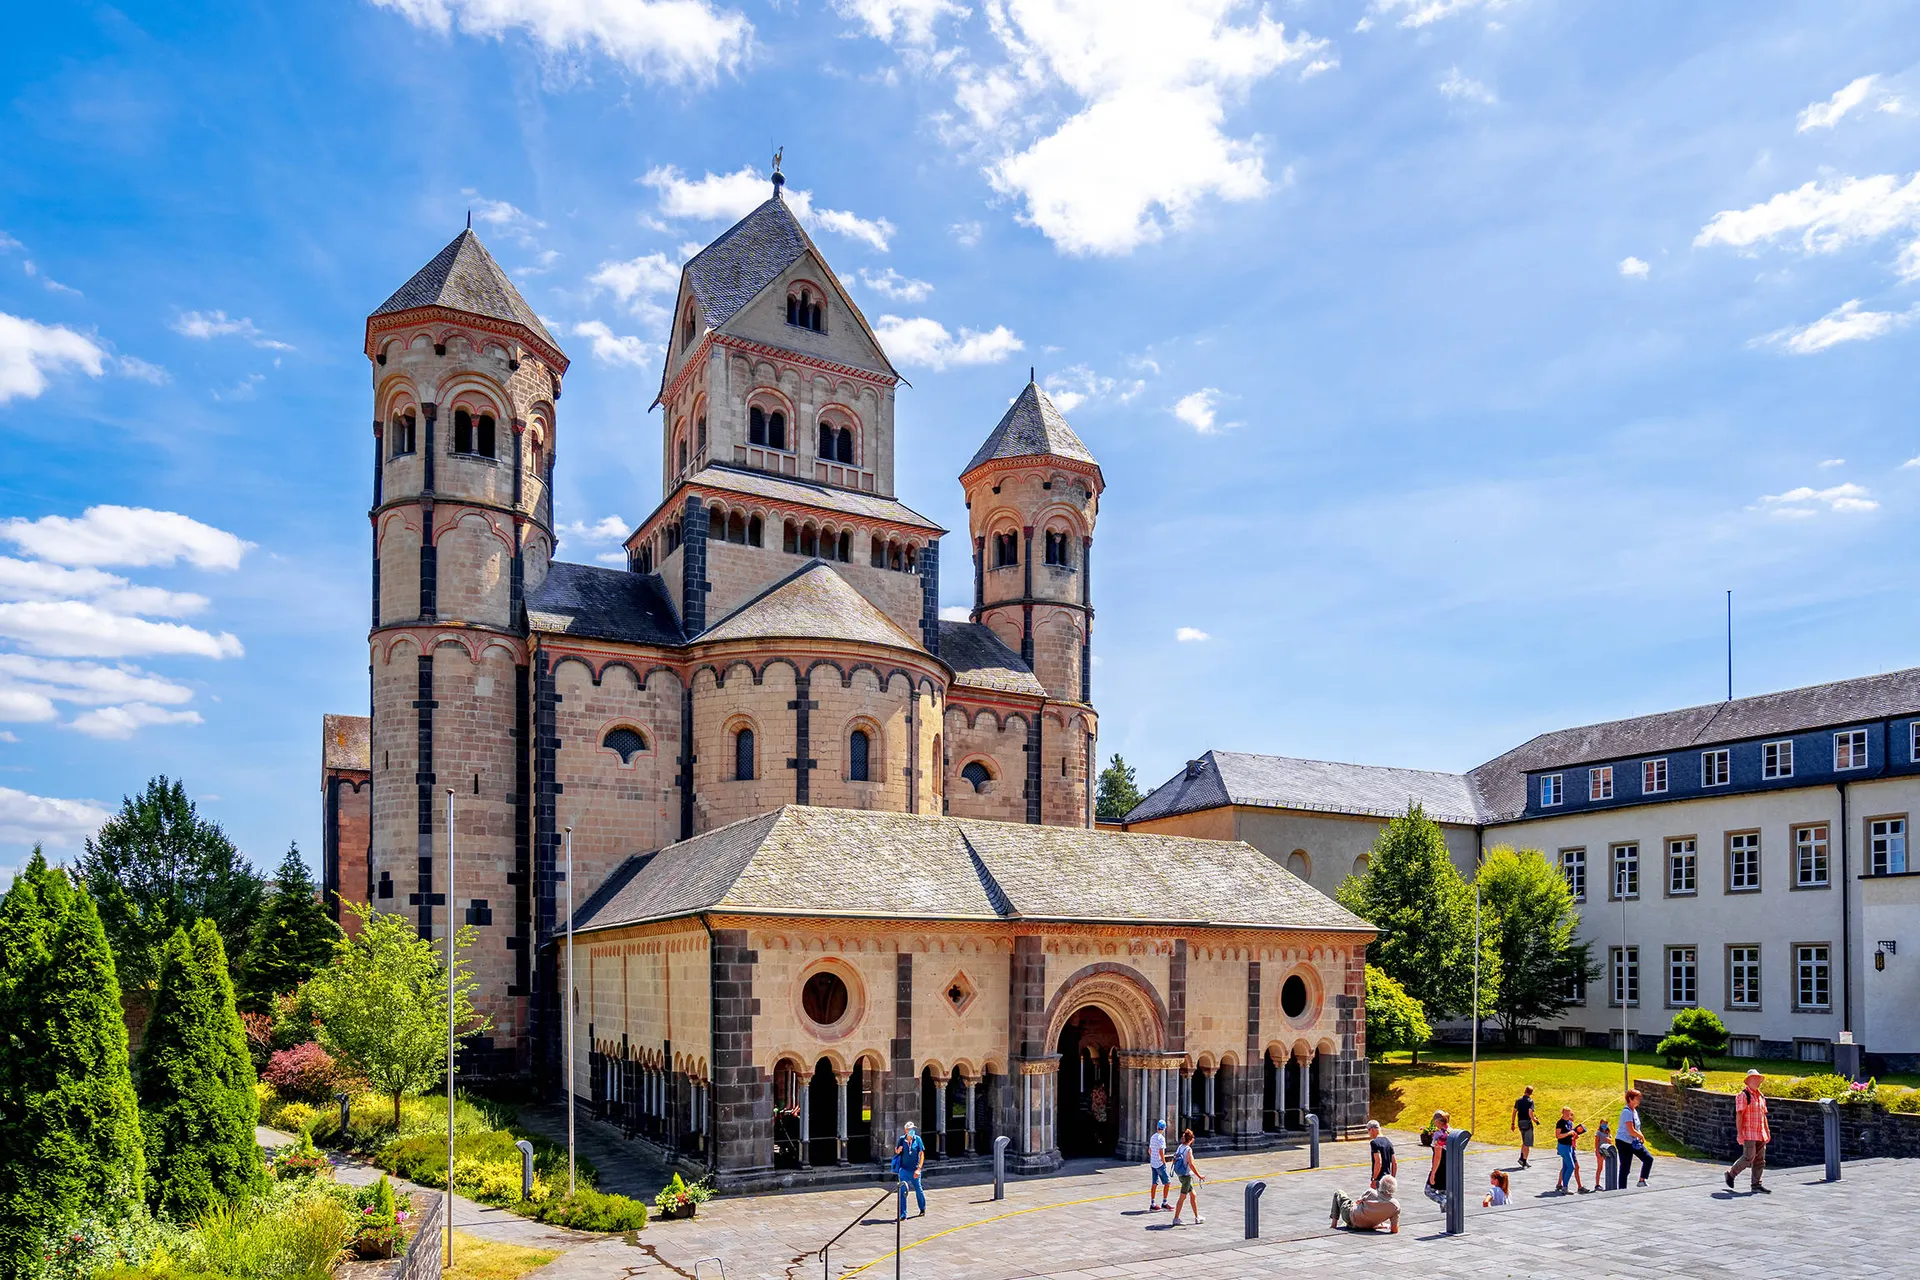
[365,228,568,1073]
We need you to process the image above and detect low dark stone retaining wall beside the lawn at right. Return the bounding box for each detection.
[1634,1080,1920,1165]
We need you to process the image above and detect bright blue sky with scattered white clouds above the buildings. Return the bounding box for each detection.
[0,0,1920,877]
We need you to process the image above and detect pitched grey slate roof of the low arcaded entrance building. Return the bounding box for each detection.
[576,806,1371,933]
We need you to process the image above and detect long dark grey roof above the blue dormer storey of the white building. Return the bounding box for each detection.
[1467,668,1920,819]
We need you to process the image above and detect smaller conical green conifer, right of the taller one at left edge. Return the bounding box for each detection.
[140,919,265,1222]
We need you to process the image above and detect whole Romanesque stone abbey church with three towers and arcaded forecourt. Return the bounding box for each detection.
[323,173,1371,1186]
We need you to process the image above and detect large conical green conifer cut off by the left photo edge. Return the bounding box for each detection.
[0,848,146,1276]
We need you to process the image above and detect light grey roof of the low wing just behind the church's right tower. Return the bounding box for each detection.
[1127,750,1480,823]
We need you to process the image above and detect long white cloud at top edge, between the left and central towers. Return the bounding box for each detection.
[372,0,753,81]
